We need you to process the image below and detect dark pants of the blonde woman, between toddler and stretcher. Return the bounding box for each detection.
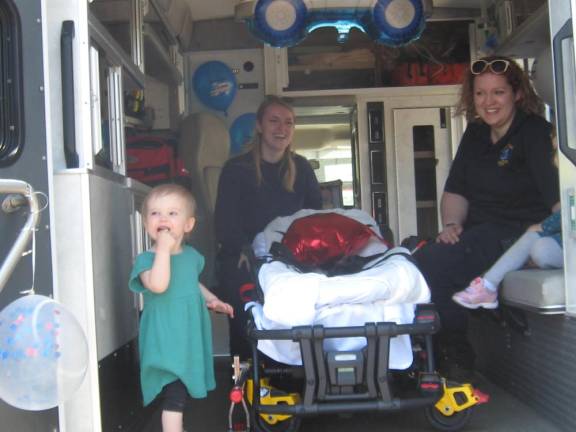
[218,256,253,359]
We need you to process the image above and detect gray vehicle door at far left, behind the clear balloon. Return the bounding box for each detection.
[0,0,58,432]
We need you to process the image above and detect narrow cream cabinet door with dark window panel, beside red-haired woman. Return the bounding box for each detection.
[394,108,451,241]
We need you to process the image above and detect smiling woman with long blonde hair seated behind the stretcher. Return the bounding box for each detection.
[214,96,322,357]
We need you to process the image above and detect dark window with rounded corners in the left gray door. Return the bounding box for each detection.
[0,1,24,167]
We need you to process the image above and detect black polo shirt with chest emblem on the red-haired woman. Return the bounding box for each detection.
[444,111,559,229]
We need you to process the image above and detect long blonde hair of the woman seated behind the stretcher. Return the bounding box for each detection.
[247,96,296,192]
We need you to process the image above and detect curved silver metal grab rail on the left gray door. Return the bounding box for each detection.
[0,179,40,292]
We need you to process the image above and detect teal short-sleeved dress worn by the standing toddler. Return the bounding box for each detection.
[129,246,216,405]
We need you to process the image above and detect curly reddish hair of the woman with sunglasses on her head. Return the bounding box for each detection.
[456,56,544,122]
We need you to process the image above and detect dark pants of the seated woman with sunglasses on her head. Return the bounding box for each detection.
[414,223,523,364]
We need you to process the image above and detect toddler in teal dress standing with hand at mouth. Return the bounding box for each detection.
[129,184,234,432]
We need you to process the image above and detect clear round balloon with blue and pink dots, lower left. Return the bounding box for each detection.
[0,295,88,411]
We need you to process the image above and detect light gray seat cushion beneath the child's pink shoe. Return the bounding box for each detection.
[501,269,566,314]
